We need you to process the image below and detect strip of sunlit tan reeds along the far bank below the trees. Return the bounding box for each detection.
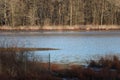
[0,25,120,31]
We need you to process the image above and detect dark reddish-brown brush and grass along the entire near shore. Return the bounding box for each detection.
[0,47,120,80]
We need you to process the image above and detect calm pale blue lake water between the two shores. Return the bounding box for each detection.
[0,31,120,62]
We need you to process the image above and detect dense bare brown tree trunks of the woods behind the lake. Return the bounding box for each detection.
[0,0,120,27]
